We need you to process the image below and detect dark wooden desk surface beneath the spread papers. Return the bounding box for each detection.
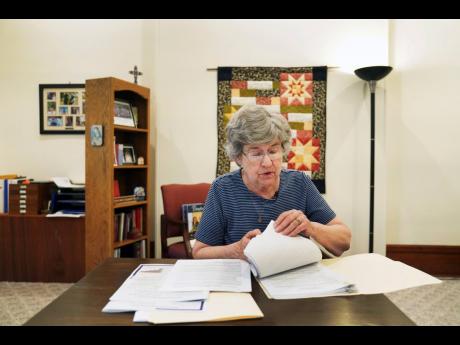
[26,259,414,326]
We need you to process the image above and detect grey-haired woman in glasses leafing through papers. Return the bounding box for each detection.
[193,106,351,259]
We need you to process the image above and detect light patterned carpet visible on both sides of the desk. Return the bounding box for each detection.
[0,278,460,326]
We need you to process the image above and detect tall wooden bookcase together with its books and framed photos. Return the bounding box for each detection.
[86,78,153,270]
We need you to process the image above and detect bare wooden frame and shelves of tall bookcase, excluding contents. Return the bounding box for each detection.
[85,78,153,272]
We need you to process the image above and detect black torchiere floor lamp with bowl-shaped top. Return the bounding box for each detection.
[355,66,393,253]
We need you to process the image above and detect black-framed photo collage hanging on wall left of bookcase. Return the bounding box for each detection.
[38,84,86,134]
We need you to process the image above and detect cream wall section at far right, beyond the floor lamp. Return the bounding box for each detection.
[386,20,460,245]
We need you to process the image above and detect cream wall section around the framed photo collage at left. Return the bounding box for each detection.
[0,20,143,181]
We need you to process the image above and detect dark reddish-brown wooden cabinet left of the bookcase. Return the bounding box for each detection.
[0,215,85,282]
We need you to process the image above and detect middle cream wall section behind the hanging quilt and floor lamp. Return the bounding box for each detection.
[146,20,388,253]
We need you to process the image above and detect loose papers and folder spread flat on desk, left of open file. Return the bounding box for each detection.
[102,260,263,323]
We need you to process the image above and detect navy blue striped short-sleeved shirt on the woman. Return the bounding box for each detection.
[195,169,335,246]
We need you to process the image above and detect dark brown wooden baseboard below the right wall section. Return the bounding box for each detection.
[387,244,460,276]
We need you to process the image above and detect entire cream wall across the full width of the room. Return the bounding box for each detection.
[0,20,460,253]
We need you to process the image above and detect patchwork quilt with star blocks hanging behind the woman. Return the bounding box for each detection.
[216,66,327,193]
